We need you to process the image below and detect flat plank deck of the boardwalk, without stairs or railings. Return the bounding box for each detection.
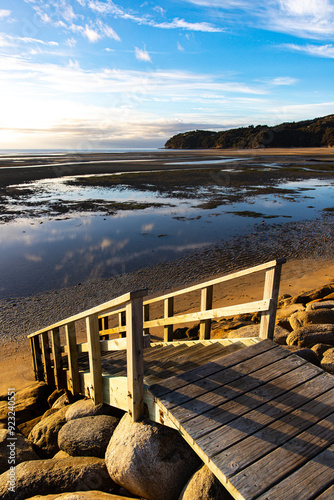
[148,340,334,500]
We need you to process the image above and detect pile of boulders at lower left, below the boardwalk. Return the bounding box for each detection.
[0,383,230,500]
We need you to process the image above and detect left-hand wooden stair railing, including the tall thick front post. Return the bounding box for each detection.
[28,290,149,419]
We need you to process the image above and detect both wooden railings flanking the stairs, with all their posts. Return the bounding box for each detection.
[28,259,285,421]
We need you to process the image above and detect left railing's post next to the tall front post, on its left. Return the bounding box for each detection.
[86,314,103,405]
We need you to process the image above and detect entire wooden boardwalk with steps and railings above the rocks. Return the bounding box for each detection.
[29,259,334,500]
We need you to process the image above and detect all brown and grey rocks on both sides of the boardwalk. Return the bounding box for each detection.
[0,284,334,500]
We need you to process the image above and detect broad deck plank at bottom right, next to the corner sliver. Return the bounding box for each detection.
[258,446,334,500]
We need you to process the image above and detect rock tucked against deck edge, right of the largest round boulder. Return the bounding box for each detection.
[179,465,233,500]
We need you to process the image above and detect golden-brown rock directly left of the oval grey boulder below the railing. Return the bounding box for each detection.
[28,407,67,458]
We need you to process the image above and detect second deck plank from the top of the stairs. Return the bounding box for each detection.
[151,347,290,409]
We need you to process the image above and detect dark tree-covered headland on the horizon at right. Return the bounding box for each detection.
[165,115,334,149]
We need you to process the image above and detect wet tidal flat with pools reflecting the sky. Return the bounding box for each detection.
[0,148,334,298]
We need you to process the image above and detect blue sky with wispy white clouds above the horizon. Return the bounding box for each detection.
[0,0,334,150]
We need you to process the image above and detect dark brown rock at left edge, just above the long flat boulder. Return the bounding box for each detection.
[0,429,39,474]
